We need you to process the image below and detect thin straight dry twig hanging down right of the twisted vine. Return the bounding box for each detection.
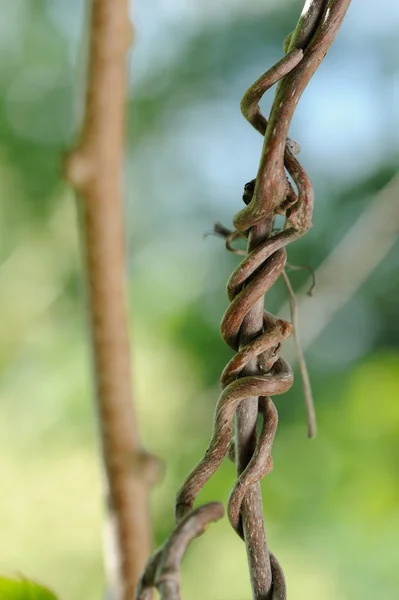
[282,271,317,438]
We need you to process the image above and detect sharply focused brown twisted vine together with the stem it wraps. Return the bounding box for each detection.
[138,0,350,600]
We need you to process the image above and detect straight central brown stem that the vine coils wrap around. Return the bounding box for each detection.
[234,0,350,600]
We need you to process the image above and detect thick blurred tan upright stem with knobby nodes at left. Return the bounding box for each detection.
[66,0,153,600]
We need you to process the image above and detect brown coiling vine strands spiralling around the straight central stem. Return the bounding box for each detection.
[176,43,313,568]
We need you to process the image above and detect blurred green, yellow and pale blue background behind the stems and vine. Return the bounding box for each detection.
[0,0,399,600]
